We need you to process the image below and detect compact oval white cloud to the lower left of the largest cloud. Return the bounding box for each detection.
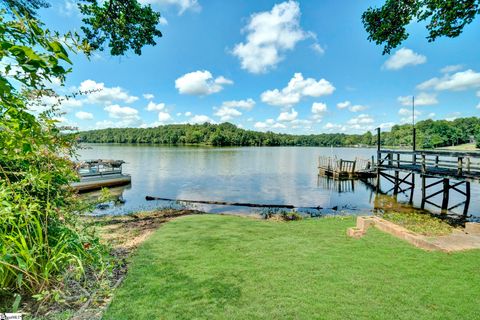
[175,70,233,96]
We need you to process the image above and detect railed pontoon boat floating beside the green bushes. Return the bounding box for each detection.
[71,159,132,192]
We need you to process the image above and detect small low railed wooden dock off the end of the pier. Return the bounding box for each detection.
[318,156,376,180]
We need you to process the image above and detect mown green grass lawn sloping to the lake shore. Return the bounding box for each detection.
[104,215,480,320]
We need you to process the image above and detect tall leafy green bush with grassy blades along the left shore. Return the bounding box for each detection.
[0,7,109,308]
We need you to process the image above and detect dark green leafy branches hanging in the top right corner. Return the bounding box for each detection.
[362,0,480,54]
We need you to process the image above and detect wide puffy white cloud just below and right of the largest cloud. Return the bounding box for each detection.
[261,73,335,107]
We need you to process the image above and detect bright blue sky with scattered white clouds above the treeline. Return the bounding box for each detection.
[41,0,480,134]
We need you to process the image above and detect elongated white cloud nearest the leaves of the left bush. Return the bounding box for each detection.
[79,80,138,104]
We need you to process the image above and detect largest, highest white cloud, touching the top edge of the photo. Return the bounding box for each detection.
[233,1,309,73]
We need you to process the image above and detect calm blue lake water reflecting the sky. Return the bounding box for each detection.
[79,144,480,220]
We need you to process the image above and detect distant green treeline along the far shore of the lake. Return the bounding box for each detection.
[79,117,480,148]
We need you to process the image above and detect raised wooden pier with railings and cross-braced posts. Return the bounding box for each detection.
[375,129,480,215]
